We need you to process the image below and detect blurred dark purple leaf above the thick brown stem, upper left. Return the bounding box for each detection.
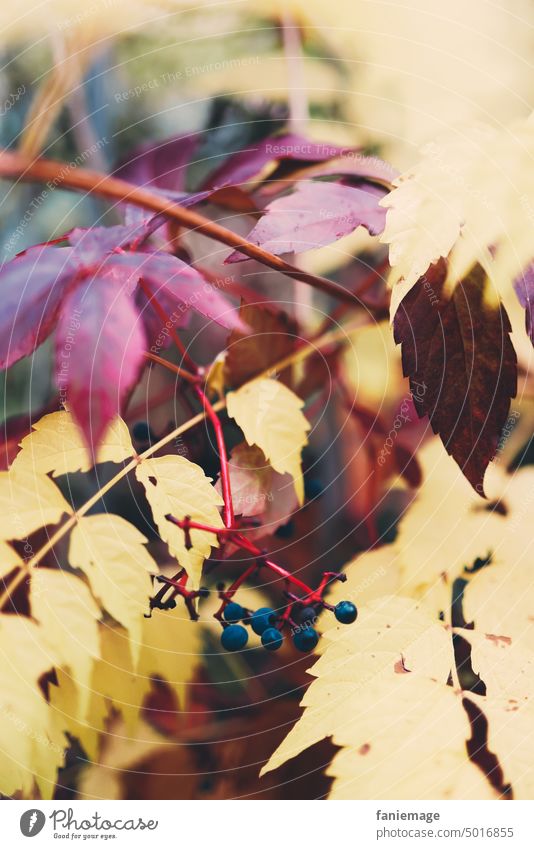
[115,133,200,192]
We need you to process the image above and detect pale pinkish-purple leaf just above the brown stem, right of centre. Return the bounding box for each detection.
[225,183,386,263]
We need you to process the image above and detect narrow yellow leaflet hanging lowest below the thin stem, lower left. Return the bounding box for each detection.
[30,569,101,717]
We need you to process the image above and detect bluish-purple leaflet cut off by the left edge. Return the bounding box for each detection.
[0,247,75,369]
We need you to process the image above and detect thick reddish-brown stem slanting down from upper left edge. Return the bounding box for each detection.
[0,150,359,304]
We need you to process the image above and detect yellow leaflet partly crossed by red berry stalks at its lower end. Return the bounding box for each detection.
[136,456,224,589]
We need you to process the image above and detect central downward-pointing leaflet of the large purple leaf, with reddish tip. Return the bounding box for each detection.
[55,272,146,458]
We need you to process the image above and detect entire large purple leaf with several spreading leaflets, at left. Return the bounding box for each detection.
[0,222,243,449]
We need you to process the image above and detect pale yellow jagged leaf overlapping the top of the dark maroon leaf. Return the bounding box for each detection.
[381,121,534,313]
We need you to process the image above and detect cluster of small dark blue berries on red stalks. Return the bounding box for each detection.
[221,600,358,652]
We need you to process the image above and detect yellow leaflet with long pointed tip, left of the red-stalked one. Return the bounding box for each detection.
[69,513,158,659]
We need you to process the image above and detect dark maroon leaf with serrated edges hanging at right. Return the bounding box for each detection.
[394,261,517,495]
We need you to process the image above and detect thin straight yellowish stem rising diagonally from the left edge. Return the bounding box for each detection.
[0,324,359,610]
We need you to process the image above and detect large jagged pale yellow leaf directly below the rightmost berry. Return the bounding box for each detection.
[263,592,493,799]
